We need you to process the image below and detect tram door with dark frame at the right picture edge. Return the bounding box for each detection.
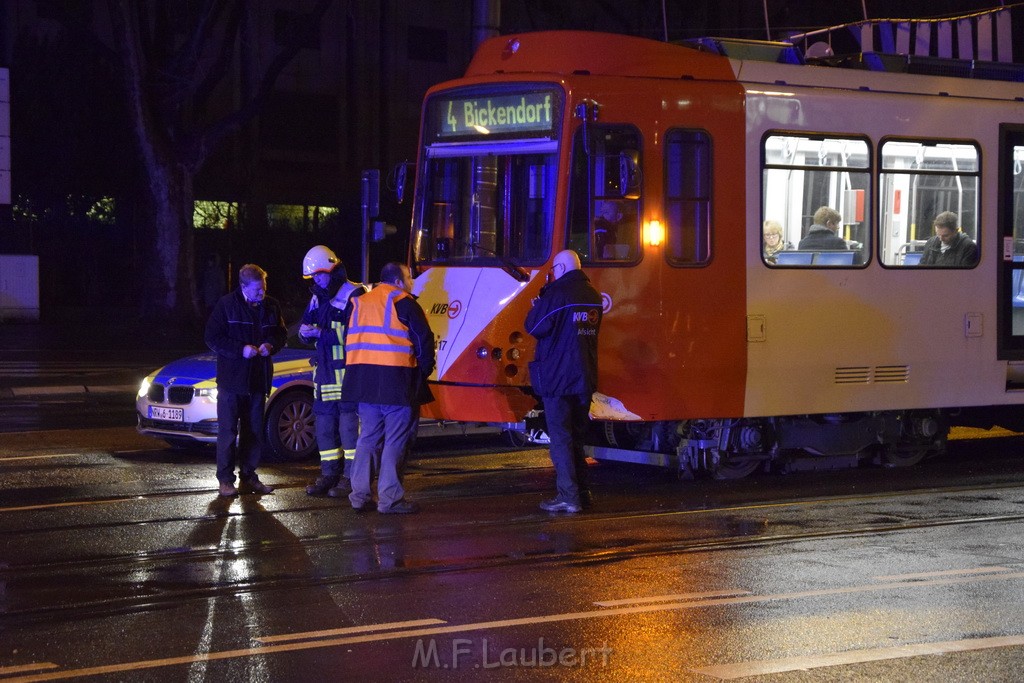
[996,124,1024,366]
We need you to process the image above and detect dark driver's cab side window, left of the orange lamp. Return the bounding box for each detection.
[566,125,641,264]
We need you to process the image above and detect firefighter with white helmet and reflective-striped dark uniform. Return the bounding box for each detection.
[299,245,366,498]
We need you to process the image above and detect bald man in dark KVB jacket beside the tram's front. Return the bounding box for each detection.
[525,250,602,513]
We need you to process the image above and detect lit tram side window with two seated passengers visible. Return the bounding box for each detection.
[757,133,871,267]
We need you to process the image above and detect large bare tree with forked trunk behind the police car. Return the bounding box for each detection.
[108,0,333,319]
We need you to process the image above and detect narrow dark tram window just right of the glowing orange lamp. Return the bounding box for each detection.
[665,129,712,265]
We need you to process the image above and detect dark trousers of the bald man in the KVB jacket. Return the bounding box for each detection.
[543,394,590,505]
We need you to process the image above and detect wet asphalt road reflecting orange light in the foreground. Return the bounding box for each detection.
[0,419,1024,682]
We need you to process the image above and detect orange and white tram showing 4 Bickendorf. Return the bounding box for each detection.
[410,32,1024,478]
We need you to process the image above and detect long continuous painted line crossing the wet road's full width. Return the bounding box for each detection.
[9,571,1024,683]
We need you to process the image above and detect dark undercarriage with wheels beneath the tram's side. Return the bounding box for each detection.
[569,411,950,479]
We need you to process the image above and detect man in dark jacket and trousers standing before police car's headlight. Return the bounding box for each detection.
[206,263,288,496]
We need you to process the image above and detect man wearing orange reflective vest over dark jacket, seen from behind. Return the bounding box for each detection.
[341,263,434,514]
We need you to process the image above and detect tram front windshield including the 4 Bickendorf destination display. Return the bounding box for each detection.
[413,85,562,265]
